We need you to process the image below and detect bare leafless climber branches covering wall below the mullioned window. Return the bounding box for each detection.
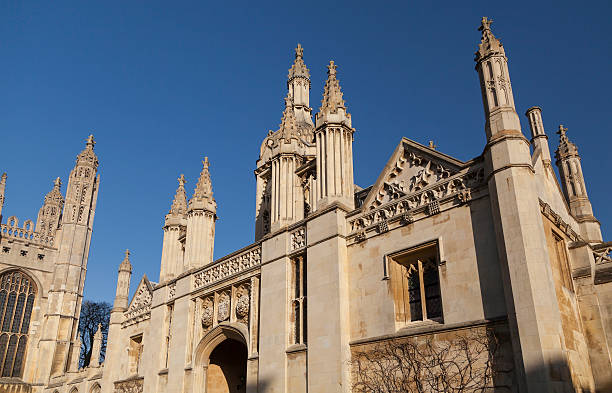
[351,329,510,393]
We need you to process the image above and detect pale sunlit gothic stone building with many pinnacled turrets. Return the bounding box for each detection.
[0,18,612,393]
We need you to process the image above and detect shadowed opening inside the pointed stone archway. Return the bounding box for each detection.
[206,339,247,393]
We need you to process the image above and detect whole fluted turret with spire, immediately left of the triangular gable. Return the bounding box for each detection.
[315,61,355,209]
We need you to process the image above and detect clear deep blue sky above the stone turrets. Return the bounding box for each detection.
[0,1,612,301]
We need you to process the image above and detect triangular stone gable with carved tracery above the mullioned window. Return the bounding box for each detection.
[363,138,465,209]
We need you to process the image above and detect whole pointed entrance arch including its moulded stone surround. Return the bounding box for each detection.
[194,324,249,393]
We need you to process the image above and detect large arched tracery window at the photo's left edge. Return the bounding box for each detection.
[0,270,36,378]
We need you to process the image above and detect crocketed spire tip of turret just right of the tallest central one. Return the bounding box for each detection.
[316,60,351,128]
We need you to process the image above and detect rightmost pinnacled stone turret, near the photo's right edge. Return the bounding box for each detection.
[555,125,602,243]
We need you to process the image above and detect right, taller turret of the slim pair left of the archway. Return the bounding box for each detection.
[184,157,217,270]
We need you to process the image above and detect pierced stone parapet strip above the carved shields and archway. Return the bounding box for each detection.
[194,245,261,289]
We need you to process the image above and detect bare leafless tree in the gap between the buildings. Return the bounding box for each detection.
[78,300,111,367]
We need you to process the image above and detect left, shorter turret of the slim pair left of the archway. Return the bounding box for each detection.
[159,174,187,282]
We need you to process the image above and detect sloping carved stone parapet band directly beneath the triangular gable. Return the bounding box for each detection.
[349,165,484,236]
